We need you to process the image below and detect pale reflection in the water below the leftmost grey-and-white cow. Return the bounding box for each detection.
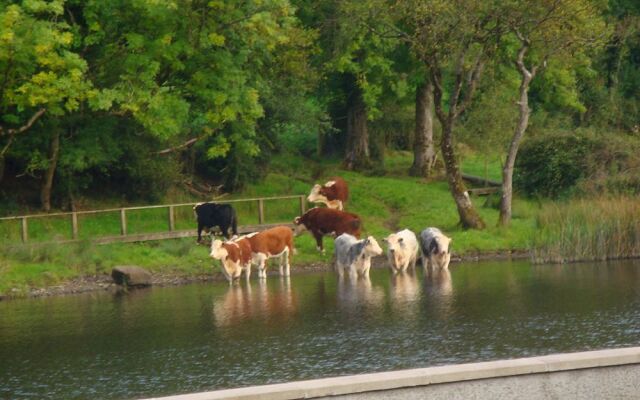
[337,276,384,313]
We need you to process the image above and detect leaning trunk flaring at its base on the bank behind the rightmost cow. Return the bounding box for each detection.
[441,120,485,229]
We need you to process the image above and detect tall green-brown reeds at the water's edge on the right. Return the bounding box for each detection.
[531,197,640,262]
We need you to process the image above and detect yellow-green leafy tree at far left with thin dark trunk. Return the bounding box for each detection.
[0,0,91,198]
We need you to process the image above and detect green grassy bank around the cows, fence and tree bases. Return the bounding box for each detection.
[0,153,537,295]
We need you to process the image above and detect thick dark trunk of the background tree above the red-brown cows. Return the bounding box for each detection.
[344,84,371,170]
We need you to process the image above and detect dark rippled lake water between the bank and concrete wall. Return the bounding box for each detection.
[0,261,640,399]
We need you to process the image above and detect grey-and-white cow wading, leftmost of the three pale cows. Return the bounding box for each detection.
[334,233,382,277]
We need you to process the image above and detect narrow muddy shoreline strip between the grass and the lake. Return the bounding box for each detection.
[0,250,529,301]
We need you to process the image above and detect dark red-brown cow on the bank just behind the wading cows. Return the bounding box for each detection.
[293,207,362,252]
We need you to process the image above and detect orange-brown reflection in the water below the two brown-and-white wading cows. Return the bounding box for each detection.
[213,277,298,326]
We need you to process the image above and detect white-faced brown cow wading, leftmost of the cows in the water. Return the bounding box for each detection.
[210,237,252,284]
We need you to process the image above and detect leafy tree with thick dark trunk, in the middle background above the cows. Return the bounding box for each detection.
[295,0,398,170]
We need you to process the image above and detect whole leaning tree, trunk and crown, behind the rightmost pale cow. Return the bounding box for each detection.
[394,0,502,229]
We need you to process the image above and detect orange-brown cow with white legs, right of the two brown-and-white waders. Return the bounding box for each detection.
[245,226,294,278]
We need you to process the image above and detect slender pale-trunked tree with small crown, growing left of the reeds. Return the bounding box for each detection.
[498,0,606,226]
